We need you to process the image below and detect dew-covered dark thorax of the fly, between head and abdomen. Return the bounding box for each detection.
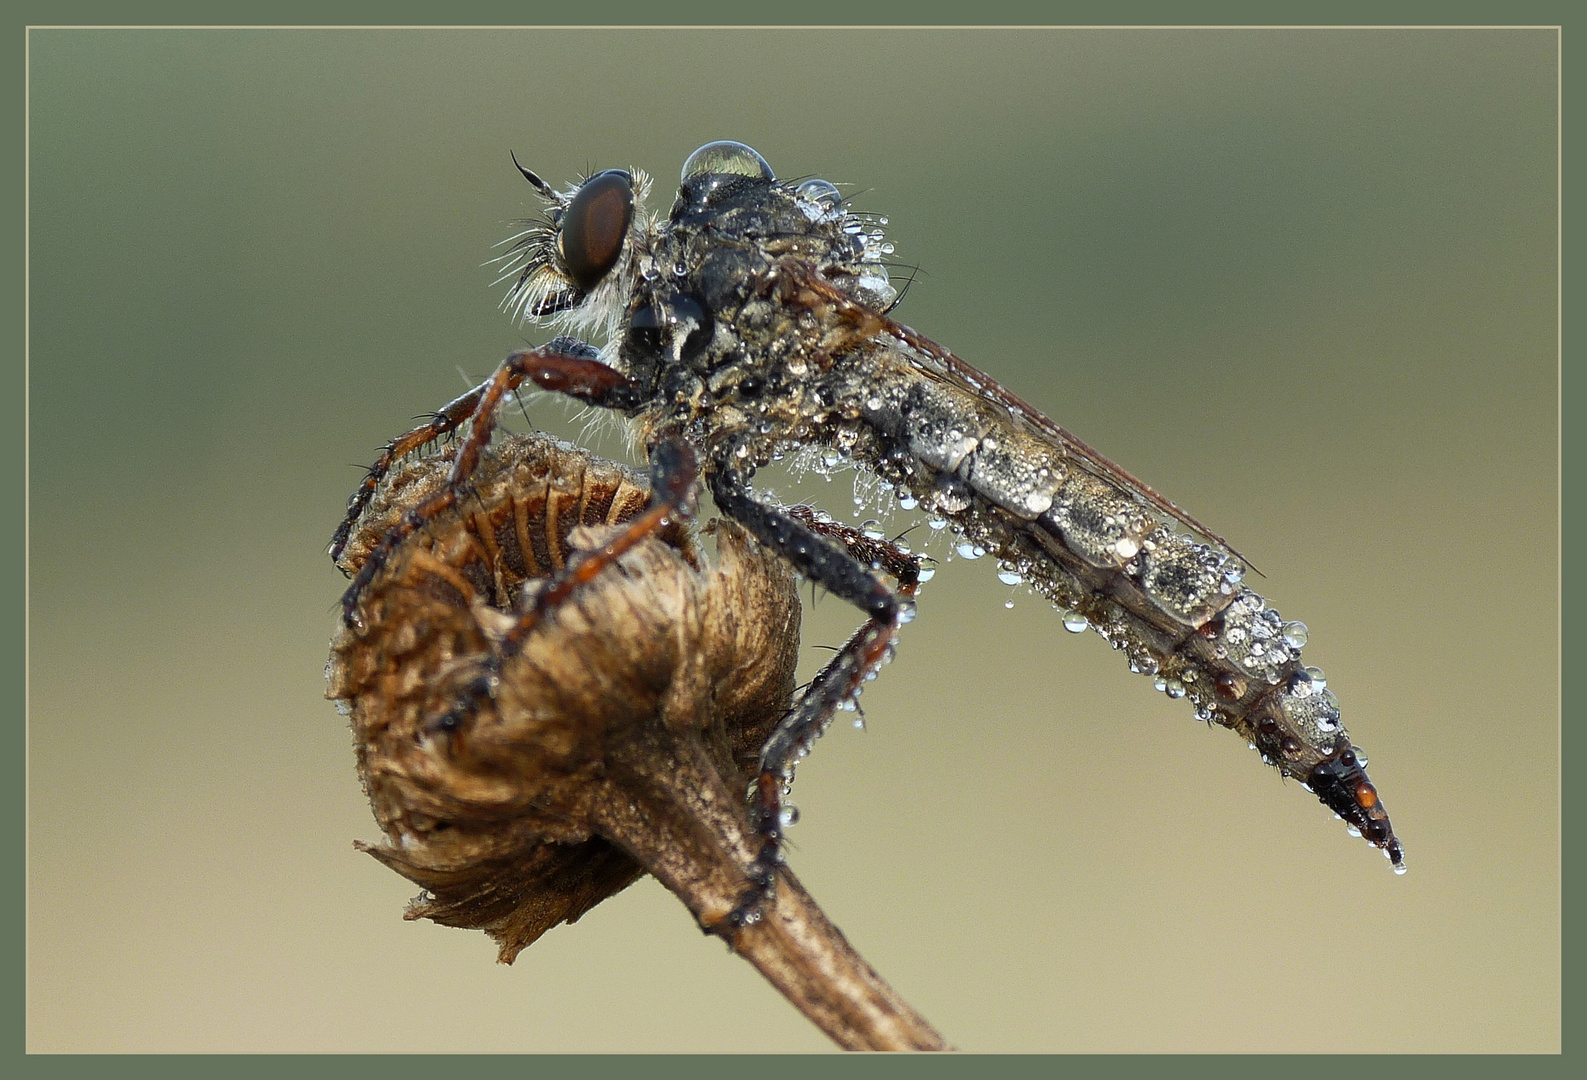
[616,174,895,466]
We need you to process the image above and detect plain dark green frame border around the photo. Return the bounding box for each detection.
[12,0,1584,1077]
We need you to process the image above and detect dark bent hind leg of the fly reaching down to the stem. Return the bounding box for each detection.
[711,469,920,926]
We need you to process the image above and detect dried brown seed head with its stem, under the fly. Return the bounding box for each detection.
[327,436,944,1048]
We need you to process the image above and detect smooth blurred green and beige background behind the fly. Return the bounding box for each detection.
[29,30,1560,1051]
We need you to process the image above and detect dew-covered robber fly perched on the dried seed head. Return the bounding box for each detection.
[332,141,1404,920]
